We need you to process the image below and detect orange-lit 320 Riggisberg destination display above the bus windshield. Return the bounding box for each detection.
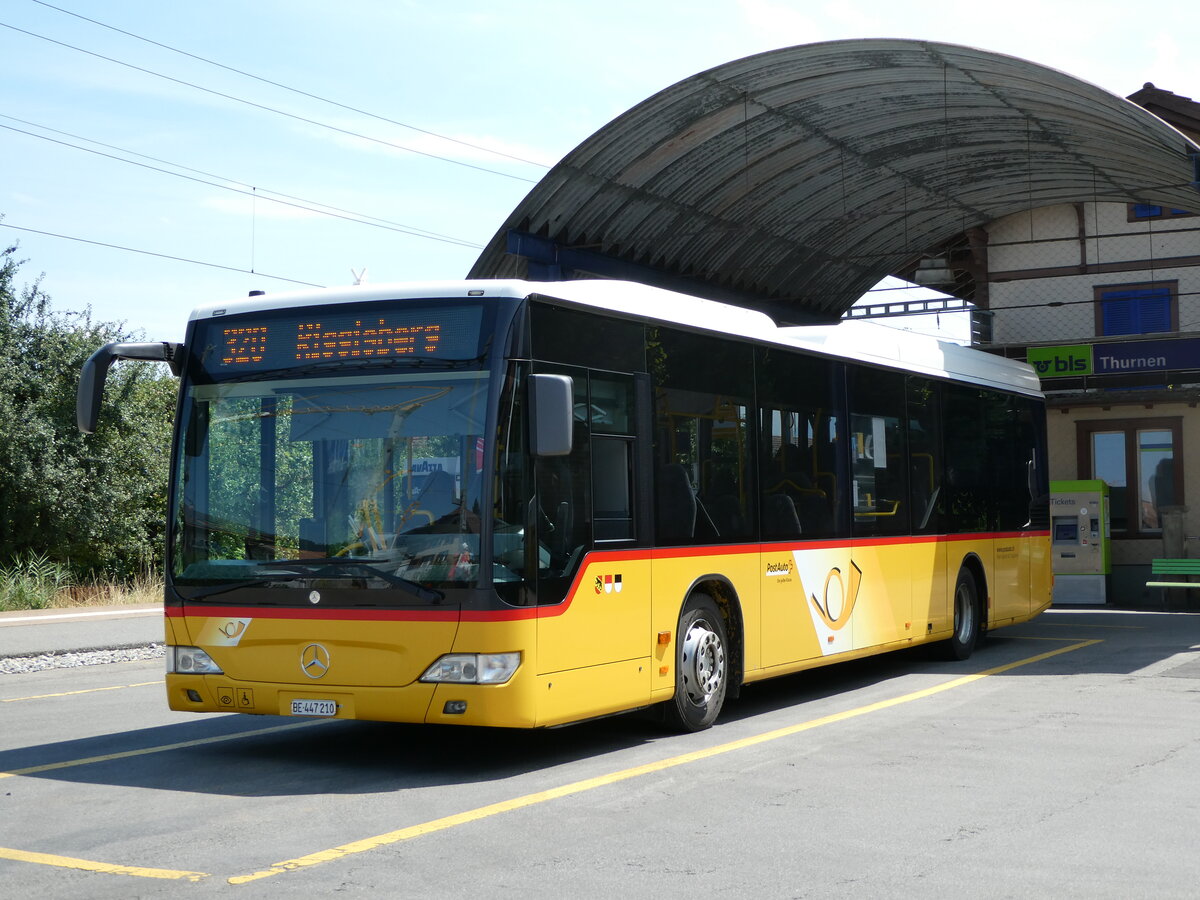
[192,302,484,376]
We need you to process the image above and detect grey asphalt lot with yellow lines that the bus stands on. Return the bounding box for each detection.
[0,608,1200,900]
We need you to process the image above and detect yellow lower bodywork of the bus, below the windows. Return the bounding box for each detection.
[167,532,1051,727]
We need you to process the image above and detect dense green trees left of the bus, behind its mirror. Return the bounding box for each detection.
[0,240,175,577]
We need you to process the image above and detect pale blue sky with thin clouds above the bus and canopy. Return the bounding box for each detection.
[0,0,1200,341]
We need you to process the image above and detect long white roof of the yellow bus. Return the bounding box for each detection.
[191,278,1042,396]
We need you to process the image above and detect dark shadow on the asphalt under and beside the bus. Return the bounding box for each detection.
[0,610,1200,797]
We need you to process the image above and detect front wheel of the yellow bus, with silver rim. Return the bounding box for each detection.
[665,593,730,732]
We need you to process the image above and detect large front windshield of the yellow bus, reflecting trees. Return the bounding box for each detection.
[170,366,488,605]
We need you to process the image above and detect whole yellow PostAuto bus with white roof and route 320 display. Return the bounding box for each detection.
[78,281,1051,731]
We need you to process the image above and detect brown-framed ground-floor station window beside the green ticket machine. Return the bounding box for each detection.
[1076,416,1183,536]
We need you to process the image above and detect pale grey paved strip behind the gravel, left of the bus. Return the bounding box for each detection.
[0,604,163,659]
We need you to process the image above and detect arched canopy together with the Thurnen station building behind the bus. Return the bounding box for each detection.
[470,40,1200,605]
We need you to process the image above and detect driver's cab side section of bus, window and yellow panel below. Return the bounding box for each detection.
[534,366,652,676]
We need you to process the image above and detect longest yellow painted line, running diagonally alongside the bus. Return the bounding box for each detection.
[229,640,1102,884]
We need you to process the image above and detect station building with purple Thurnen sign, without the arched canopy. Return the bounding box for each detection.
[931,84,1200,606]
